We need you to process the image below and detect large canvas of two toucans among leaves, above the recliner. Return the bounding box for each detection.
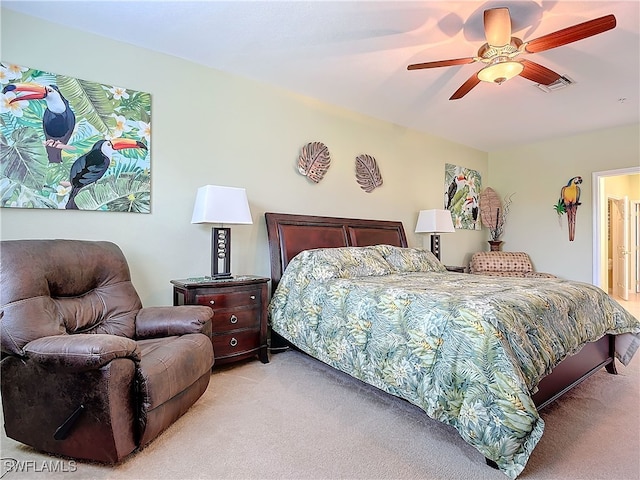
[0,62,151,213]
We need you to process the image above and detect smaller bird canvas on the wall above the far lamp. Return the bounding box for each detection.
[444,163,482,230]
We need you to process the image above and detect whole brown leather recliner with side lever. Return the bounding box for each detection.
[0,240,213,463]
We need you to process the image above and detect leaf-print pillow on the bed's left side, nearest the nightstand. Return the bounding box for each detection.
[287,247,393,280]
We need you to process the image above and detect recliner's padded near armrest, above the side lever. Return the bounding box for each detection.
[23,333,140,372]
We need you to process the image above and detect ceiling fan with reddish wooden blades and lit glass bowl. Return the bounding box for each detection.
[407,7,616,100]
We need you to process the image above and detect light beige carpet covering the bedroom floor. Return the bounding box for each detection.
[0,351,640,480]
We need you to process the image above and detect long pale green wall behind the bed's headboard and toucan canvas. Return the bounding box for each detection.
[0,10,487,305]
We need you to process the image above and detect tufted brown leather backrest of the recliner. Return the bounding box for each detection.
[0,240,142,355]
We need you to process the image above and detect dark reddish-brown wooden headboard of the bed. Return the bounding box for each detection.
[264,212,407,291]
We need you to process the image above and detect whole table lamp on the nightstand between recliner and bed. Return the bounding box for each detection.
[191,185,253,279]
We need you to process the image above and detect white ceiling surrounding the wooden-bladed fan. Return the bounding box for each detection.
[2,0,640,152]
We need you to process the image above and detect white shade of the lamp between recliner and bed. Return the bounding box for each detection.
[191,185,253,224]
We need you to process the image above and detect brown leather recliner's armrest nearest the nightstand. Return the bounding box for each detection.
[136,305,213,339]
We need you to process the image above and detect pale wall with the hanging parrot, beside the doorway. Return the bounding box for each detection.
[487,125,640,283]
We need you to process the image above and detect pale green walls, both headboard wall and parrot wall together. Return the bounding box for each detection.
[0,9,640,305]
